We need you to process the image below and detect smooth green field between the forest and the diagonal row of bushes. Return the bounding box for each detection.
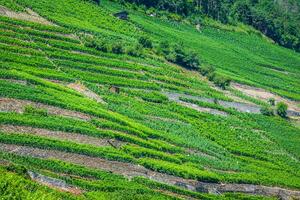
[103,1,300,100]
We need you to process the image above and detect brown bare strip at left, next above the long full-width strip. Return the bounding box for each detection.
[0,125,125,148]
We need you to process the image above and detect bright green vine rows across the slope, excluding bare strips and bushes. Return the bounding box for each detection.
[0,0,300,199]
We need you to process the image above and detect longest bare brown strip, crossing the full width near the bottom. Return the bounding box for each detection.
[0,144,300,200]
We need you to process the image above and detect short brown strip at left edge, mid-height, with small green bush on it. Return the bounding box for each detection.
[0,98,91,120]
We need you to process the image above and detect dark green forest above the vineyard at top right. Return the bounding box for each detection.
[119,0,300,51]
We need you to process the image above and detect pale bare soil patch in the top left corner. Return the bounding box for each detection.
[0,6,55,26]
